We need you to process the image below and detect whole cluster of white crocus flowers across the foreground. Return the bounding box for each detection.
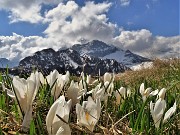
[3,70,176,135]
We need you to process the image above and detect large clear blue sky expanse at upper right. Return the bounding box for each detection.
[109,0,179,36]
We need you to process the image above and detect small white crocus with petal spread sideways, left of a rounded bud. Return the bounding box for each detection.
[139,83,158,102]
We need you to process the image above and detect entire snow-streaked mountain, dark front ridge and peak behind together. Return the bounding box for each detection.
[0,40,150,75]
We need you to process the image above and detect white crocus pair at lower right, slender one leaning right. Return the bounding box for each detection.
[150,98,176,128]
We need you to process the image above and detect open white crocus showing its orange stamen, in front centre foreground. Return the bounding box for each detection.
[76,97,101,132]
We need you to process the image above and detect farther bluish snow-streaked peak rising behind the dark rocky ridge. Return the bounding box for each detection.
[71,40,150,66]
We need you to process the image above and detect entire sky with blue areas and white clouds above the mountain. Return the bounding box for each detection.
[0,0,180,62]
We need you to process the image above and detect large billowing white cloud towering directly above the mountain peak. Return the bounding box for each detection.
[44,1,117,44]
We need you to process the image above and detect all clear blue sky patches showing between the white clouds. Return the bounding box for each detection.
[0,0,180,36]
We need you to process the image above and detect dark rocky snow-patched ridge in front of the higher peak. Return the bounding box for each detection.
[19,49,129,75]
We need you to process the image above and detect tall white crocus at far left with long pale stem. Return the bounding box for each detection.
[6,72,40,131]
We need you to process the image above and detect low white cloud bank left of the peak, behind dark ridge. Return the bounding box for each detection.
[0,33,63,62]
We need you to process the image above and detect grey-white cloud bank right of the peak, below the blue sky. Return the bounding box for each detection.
[113,29,180,58]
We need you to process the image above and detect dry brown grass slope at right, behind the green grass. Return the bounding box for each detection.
[116,59,180,85]
